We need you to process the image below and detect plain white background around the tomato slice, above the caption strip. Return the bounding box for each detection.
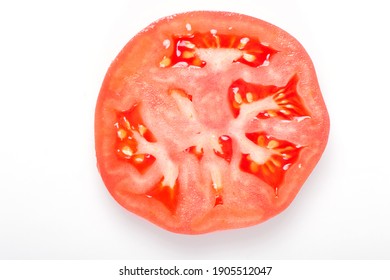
[0,0,390,259]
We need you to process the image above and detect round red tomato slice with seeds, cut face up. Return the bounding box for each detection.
[95,11,329,234]
